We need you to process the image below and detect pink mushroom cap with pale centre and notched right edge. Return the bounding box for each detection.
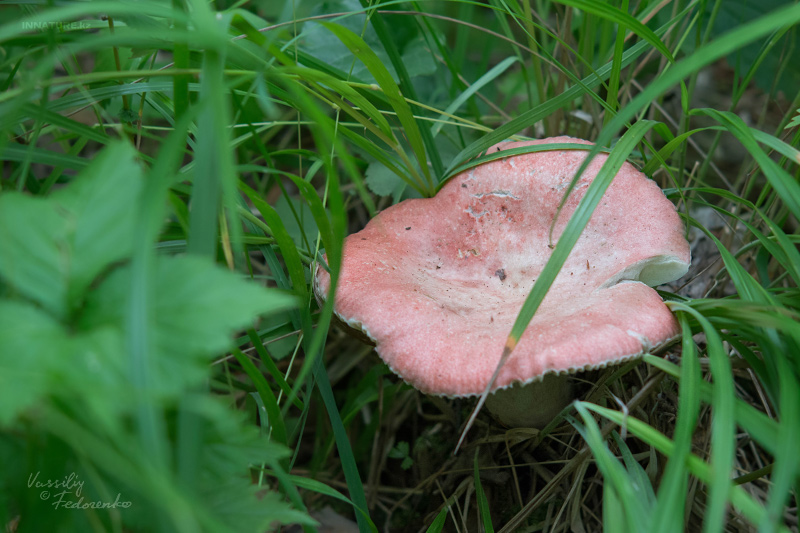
[314,137,690,397]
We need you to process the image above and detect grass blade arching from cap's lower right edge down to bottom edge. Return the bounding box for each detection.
[672,302,736,531]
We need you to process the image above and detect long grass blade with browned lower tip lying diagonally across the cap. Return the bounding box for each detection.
[454,120,655,453]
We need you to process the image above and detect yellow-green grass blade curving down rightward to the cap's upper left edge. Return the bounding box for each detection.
[320,22,435,195]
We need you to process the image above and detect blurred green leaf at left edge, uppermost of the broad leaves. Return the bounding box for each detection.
[0,142,142,318]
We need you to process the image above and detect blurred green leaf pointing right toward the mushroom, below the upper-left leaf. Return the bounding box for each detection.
[80,256,296,394]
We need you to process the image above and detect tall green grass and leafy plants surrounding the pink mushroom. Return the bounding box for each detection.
[0,0,800,532]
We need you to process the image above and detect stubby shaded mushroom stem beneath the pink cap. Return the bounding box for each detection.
[486,374,573,429]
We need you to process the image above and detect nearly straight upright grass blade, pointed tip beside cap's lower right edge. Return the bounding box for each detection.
[651,315,700,533]
